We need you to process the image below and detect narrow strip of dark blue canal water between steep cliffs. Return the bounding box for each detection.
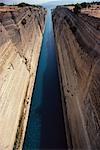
[23,10,67,150]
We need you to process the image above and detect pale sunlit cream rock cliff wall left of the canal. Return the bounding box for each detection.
[0,7,46,150]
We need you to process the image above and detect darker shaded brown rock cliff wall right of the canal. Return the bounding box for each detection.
[53,7,100,149]
